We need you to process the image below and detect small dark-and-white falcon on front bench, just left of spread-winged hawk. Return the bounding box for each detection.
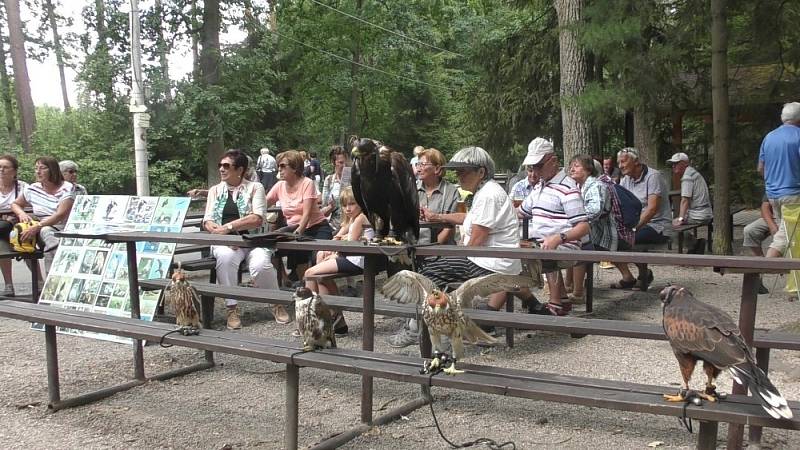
[292,287,336,352]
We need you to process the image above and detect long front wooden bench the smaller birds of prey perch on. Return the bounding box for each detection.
[0,301,800,449]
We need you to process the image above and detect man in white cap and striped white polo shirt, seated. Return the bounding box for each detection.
[520,138,591,316]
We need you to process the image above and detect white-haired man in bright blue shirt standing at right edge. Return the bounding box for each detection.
[758,102,800,258]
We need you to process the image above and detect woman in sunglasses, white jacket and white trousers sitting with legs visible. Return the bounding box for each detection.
[203,150,282,330]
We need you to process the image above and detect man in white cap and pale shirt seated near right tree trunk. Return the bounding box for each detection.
[667,153,714,253]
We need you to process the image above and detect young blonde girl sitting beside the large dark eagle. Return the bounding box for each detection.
[305,187,374,334]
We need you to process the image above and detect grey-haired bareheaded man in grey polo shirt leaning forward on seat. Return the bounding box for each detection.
[611,147,672,290]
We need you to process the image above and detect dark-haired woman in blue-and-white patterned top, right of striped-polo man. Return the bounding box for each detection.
[569,155,618,303]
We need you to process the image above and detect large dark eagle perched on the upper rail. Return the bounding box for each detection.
[351,138,419,245]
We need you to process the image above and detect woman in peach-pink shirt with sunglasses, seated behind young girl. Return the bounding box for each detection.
[267,150,333,281]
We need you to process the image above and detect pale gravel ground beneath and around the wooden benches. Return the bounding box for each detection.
[0,267,800,449]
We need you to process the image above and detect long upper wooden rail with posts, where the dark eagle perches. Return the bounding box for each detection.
[57,232,800,447]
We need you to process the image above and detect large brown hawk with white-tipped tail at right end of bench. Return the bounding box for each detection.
[661,286,792,419]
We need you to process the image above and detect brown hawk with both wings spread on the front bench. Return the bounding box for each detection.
[382,270,536,375]
